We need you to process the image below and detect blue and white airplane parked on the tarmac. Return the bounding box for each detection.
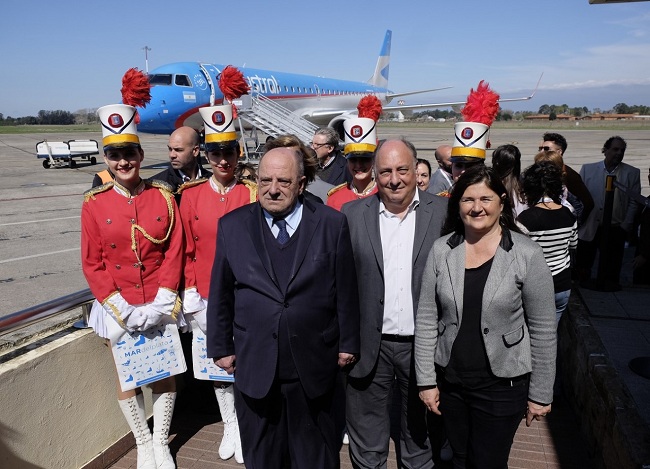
[138,30,541,135]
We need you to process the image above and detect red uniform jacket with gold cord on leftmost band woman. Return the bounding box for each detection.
[81,182,183,305]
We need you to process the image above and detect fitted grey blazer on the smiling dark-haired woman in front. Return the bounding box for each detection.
[414,230,556,404]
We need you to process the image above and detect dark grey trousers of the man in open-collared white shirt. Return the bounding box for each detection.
[346,340,433,469]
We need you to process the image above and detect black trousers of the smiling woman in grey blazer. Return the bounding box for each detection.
[439,377,528,469]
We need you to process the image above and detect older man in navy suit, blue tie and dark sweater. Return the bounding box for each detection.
[207,147,359,469]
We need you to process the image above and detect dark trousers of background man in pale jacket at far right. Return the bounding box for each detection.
[577,225,627,285]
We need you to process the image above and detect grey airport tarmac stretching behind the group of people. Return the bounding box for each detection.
[0,123,650,317]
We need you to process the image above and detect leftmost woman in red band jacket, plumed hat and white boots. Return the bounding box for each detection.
[81,104,184,469]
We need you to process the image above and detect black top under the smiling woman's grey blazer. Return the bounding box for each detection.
[445,258,499,389]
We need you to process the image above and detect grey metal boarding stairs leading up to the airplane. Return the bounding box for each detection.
[235,94,318,154]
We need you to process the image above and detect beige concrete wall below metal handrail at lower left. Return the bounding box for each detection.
[0,329,137,469]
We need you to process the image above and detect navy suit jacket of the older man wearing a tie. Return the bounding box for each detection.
[207,199,359,399]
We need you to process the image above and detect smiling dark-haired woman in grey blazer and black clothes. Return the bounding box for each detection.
[414,165,556,468]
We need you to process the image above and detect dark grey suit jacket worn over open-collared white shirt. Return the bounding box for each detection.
[342,189,448,378]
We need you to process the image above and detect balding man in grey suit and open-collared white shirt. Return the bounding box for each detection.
[342,140,447,468]
